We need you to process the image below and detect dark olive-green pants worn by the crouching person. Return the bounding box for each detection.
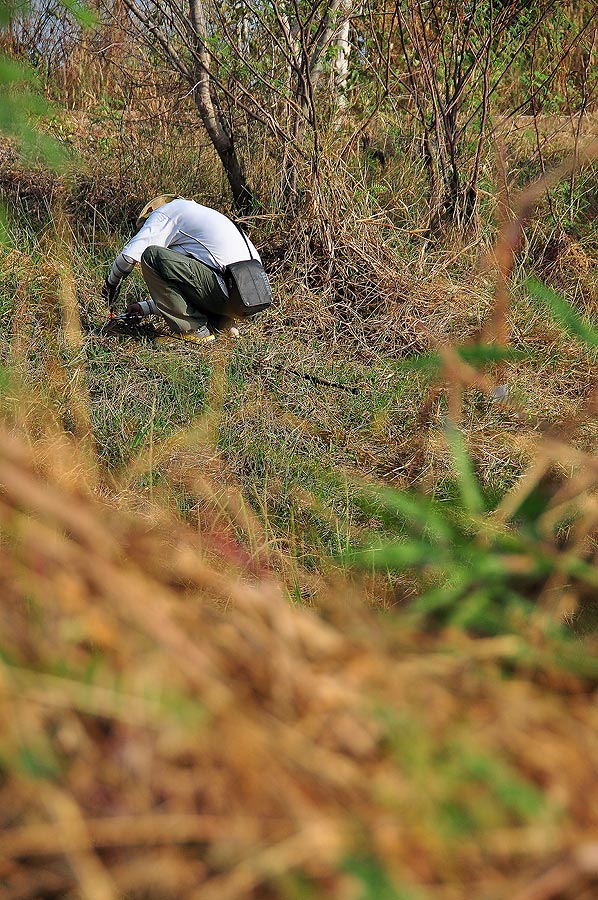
[141,247,227,333]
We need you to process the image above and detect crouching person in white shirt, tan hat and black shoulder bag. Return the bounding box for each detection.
[103,195,271,343]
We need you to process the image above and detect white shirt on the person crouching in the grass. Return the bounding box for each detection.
[121,199,261,269]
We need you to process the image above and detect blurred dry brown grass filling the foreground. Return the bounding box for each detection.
[0,429,598,900]
